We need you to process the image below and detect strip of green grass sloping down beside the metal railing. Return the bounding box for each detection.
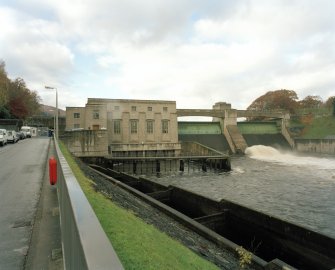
[60,143,218,270]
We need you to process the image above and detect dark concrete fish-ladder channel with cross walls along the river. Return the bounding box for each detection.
[91,165,335,270]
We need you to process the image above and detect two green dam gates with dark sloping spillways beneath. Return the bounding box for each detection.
[178,121,292,153]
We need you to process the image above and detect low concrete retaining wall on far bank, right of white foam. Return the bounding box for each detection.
[294,139,335,154]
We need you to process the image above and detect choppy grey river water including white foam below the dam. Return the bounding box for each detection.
[151,145,335,238]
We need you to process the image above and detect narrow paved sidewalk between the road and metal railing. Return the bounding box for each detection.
[25,140,63,270]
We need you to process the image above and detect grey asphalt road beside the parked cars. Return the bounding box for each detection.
[0,137,50,269]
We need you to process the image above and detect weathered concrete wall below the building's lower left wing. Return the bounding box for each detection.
[61,130,108,157]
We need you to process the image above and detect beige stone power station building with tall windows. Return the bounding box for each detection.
[66,98,181,157]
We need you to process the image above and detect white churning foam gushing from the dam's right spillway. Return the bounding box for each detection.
[245,145,335,169]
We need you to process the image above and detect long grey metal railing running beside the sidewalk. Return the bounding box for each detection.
[55,139,124,270]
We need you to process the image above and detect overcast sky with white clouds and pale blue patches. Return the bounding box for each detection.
[0,0,335,109]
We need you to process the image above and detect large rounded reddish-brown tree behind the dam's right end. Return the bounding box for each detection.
[247,89,298,113]
